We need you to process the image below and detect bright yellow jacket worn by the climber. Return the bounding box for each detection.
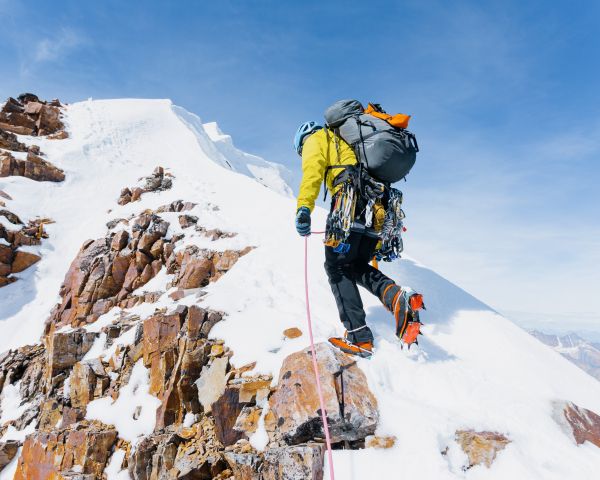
[296,128,356,212]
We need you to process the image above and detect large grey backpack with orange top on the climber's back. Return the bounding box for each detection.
[325,100,419,184]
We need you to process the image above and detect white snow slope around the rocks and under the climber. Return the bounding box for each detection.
[0,100,600,480]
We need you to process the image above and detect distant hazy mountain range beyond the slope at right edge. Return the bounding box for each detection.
[530,330,600,380]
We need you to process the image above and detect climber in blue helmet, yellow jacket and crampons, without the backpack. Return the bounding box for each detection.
[294,115,423,357]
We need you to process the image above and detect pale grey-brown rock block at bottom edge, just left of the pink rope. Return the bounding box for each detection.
[262,444,323,480]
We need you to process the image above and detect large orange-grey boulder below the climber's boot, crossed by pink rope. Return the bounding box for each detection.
[267,343,379,445]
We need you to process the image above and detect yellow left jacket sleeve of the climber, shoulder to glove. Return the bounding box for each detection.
[296,135,327,212]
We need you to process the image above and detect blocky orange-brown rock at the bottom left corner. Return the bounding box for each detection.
[14,421,117,480]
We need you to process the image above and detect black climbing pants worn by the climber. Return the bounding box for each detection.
[325,232,394,343]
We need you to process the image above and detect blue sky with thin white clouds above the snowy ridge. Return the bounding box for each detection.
[0,0,600,330]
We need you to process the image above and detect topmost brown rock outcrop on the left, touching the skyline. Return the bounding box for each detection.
[0,93,65,136]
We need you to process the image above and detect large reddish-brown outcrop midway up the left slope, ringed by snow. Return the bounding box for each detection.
[48,213,249,327]
